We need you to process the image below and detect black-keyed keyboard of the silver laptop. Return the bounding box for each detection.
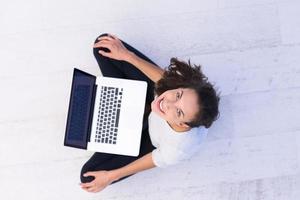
[95,86,123,144]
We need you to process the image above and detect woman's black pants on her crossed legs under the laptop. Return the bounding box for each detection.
[80,34,155,183]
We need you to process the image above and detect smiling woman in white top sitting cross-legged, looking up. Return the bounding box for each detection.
[80,34,219,192]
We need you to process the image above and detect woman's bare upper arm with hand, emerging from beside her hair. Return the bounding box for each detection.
[94,34,164,82]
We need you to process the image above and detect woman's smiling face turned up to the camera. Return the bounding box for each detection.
[151,88,199,128]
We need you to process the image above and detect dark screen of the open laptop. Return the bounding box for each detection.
[64,68,96,149]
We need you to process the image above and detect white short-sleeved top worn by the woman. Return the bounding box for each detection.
[148,112,208,168]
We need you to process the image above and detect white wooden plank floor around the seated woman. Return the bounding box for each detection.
[0,0,300,200]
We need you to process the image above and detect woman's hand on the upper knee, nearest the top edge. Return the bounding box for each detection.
[94,34,130,61]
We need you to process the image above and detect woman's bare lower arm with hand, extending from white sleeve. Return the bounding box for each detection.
[80,152,155,192]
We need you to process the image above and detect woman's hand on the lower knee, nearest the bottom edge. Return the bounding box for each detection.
[80,171,114,192]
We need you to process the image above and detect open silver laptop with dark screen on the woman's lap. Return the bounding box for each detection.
[64,68,147,156]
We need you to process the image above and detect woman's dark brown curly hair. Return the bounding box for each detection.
[154,58,220,128]
